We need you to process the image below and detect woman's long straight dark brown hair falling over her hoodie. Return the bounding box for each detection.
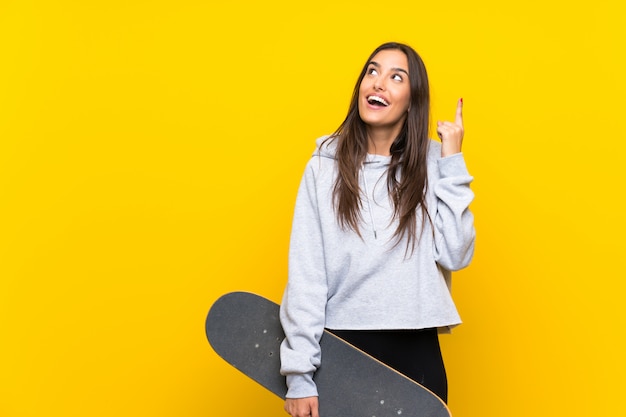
[328,42,430,252]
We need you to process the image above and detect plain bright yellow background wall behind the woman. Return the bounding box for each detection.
[0,0,626,417]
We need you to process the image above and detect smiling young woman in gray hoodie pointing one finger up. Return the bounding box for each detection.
[281,43,475,417]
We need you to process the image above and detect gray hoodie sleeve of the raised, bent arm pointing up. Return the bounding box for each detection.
[434,153,476,271]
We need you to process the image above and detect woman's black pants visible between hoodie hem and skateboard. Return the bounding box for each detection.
[328,329,448,402]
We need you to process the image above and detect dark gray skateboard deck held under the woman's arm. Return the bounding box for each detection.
[206,292,450,417]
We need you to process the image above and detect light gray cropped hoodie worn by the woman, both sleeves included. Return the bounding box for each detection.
[280,137,475,398]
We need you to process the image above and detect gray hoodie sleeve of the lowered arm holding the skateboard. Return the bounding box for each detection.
[280,163,328,398]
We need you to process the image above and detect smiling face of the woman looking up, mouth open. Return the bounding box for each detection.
[358,49,411,135]
